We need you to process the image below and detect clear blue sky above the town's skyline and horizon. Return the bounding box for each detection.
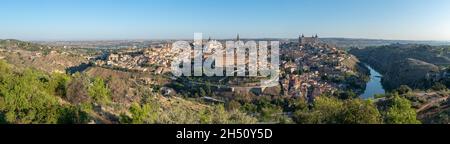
[0,0,450,41]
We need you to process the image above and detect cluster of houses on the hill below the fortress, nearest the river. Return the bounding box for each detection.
[280,35,355,101]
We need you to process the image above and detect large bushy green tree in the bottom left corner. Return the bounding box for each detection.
[0,69,60,124]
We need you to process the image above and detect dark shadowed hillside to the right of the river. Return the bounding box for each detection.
[350,44,450,89]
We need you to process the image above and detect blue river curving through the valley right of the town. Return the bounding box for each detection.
[361,65,385,99]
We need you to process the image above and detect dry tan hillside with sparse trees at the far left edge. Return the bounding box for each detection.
[0,40,93,73]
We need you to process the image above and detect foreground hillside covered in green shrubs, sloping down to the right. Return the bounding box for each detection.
[0,60,256,124]
